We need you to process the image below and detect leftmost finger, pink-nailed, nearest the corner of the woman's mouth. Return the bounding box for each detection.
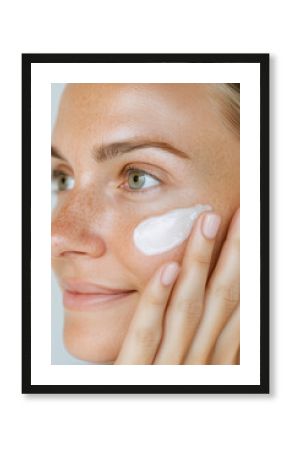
[115,262,180,364]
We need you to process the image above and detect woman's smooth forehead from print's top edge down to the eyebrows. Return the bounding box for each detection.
[53,83,232,163]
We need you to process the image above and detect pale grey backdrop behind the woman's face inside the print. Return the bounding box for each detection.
[51,83,89,364]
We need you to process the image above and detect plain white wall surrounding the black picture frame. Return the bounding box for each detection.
[0,0,290,450]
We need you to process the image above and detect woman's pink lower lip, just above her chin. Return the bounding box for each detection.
[63,290,136,311]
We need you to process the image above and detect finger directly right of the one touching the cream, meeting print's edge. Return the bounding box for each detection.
[185,210,240,364]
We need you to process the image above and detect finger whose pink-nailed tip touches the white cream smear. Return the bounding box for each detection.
[155,213,221,364]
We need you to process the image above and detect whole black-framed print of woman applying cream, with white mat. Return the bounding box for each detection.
[22,53,269,394]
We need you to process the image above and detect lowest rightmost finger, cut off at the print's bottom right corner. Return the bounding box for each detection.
[210,305,240,364]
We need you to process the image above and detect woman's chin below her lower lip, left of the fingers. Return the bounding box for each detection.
[63,302,136,364]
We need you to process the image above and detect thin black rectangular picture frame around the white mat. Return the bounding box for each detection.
[22,53,270,394]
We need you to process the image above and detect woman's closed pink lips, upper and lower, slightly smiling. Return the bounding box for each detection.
[61,280,136,311]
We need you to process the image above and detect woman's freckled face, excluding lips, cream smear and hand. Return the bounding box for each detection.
[52,84,240,362]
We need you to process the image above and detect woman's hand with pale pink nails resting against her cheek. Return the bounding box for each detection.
[114,210,240,364]
